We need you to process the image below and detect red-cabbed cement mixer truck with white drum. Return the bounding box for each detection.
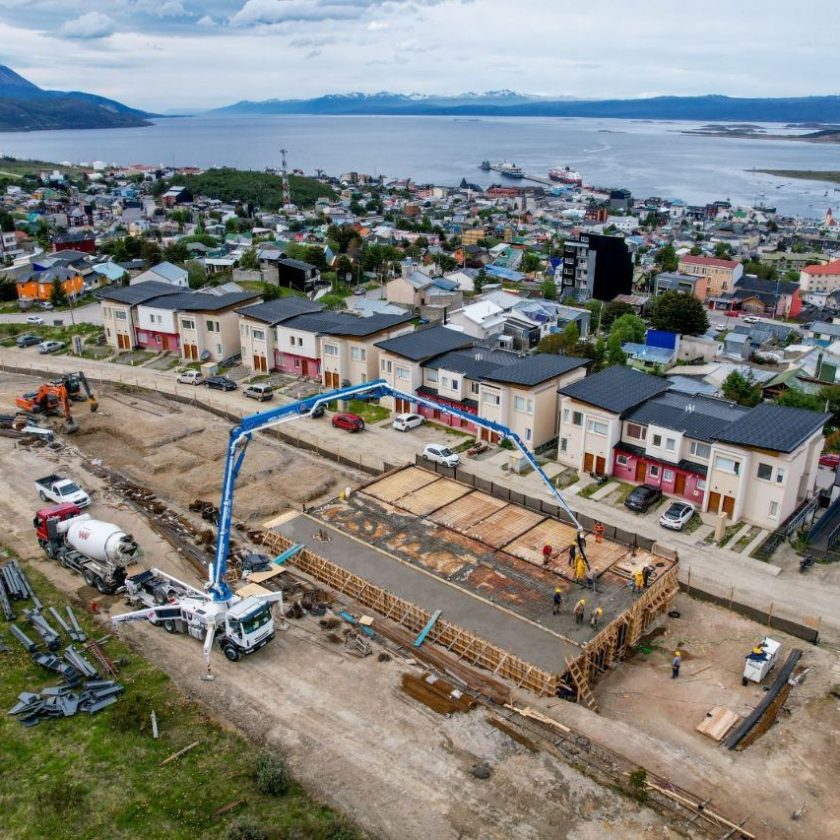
[33,503,142,595]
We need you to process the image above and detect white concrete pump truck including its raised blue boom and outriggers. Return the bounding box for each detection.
[111,379,586,676]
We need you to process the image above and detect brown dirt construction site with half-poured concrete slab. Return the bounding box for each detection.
[0,374,840,838]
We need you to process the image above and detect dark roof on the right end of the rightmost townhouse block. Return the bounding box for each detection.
[715,403,831,452]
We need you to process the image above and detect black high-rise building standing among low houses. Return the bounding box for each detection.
[560,233,633,301]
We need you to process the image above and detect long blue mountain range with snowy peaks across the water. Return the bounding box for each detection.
[209,90,840,123]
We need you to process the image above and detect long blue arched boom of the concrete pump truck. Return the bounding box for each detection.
[208,379,586,601]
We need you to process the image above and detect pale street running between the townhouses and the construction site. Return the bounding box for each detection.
[6,348,840,643]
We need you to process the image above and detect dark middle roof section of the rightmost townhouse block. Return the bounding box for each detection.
[625,391,749,442]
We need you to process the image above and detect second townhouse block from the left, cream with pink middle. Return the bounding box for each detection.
[239,297,413,378]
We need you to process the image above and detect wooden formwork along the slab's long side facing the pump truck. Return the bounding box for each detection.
[263,531,558,695]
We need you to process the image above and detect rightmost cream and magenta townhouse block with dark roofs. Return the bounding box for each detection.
[557,366,830,530]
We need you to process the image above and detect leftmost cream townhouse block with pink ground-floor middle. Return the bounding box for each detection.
[100,280,260,362]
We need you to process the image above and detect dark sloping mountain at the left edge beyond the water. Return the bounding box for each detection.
[0,65,156,131]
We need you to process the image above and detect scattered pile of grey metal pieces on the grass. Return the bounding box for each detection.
[0,560,124,726]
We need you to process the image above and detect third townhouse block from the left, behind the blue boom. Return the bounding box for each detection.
[370,327,587,448]
